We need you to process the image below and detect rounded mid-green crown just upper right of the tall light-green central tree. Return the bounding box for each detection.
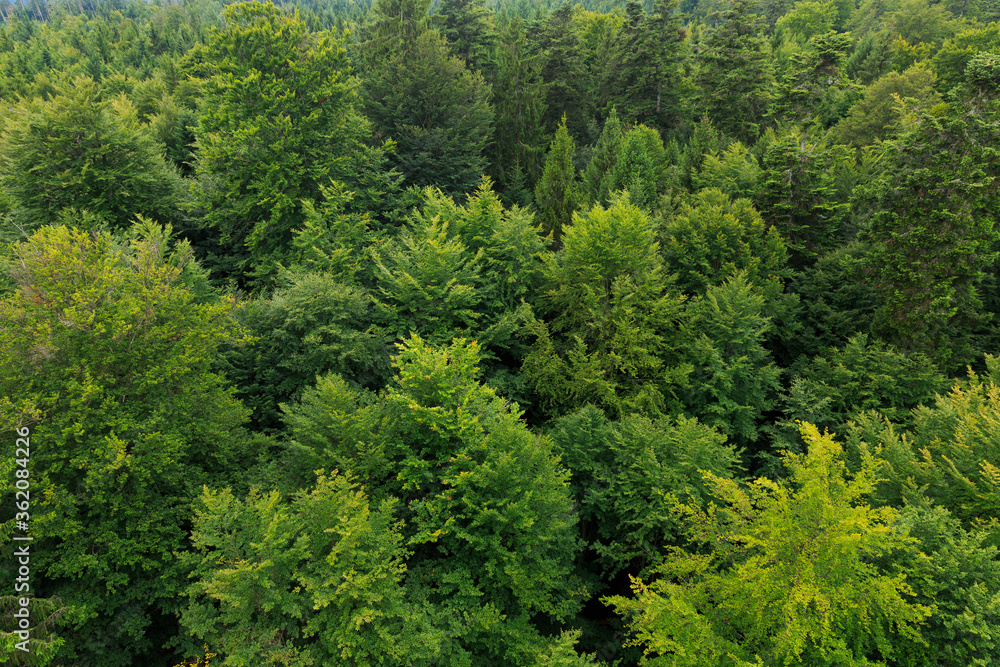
[662,188,788,298]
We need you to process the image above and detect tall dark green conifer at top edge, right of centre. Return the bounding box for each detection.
[697,0,774,143]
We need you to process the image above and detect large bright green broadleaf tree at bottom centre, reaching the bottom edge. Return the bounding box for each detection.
[286,337,583,666]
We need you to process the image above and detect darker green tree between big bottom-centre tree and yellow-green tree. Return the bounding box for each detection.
[550,405,740,579]
